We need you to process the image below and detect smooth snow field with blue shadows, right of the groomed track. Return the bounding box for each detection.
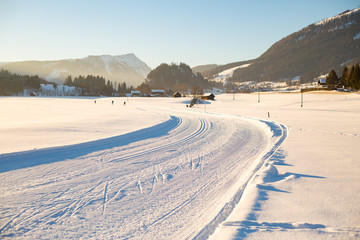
[210,92,360,239]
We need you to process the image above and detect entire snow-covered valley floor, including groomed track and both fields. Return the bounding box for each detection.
[0,93,360,239]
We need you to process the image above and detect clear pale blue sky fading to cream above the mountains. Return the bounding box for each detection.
[0,0,360,68]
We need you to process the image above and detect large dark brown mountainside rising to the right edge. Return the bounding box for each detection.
[208,9,360,82]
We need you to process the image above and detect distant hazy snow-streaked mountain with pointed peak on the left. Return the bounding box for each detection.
[0,53,151,87]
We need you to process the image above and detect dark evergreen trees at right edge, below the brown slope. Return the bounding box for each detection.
[326,63,360,90]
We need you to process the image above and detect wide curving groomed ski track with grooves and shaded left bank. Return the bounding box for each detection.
[0,103,287,239]
